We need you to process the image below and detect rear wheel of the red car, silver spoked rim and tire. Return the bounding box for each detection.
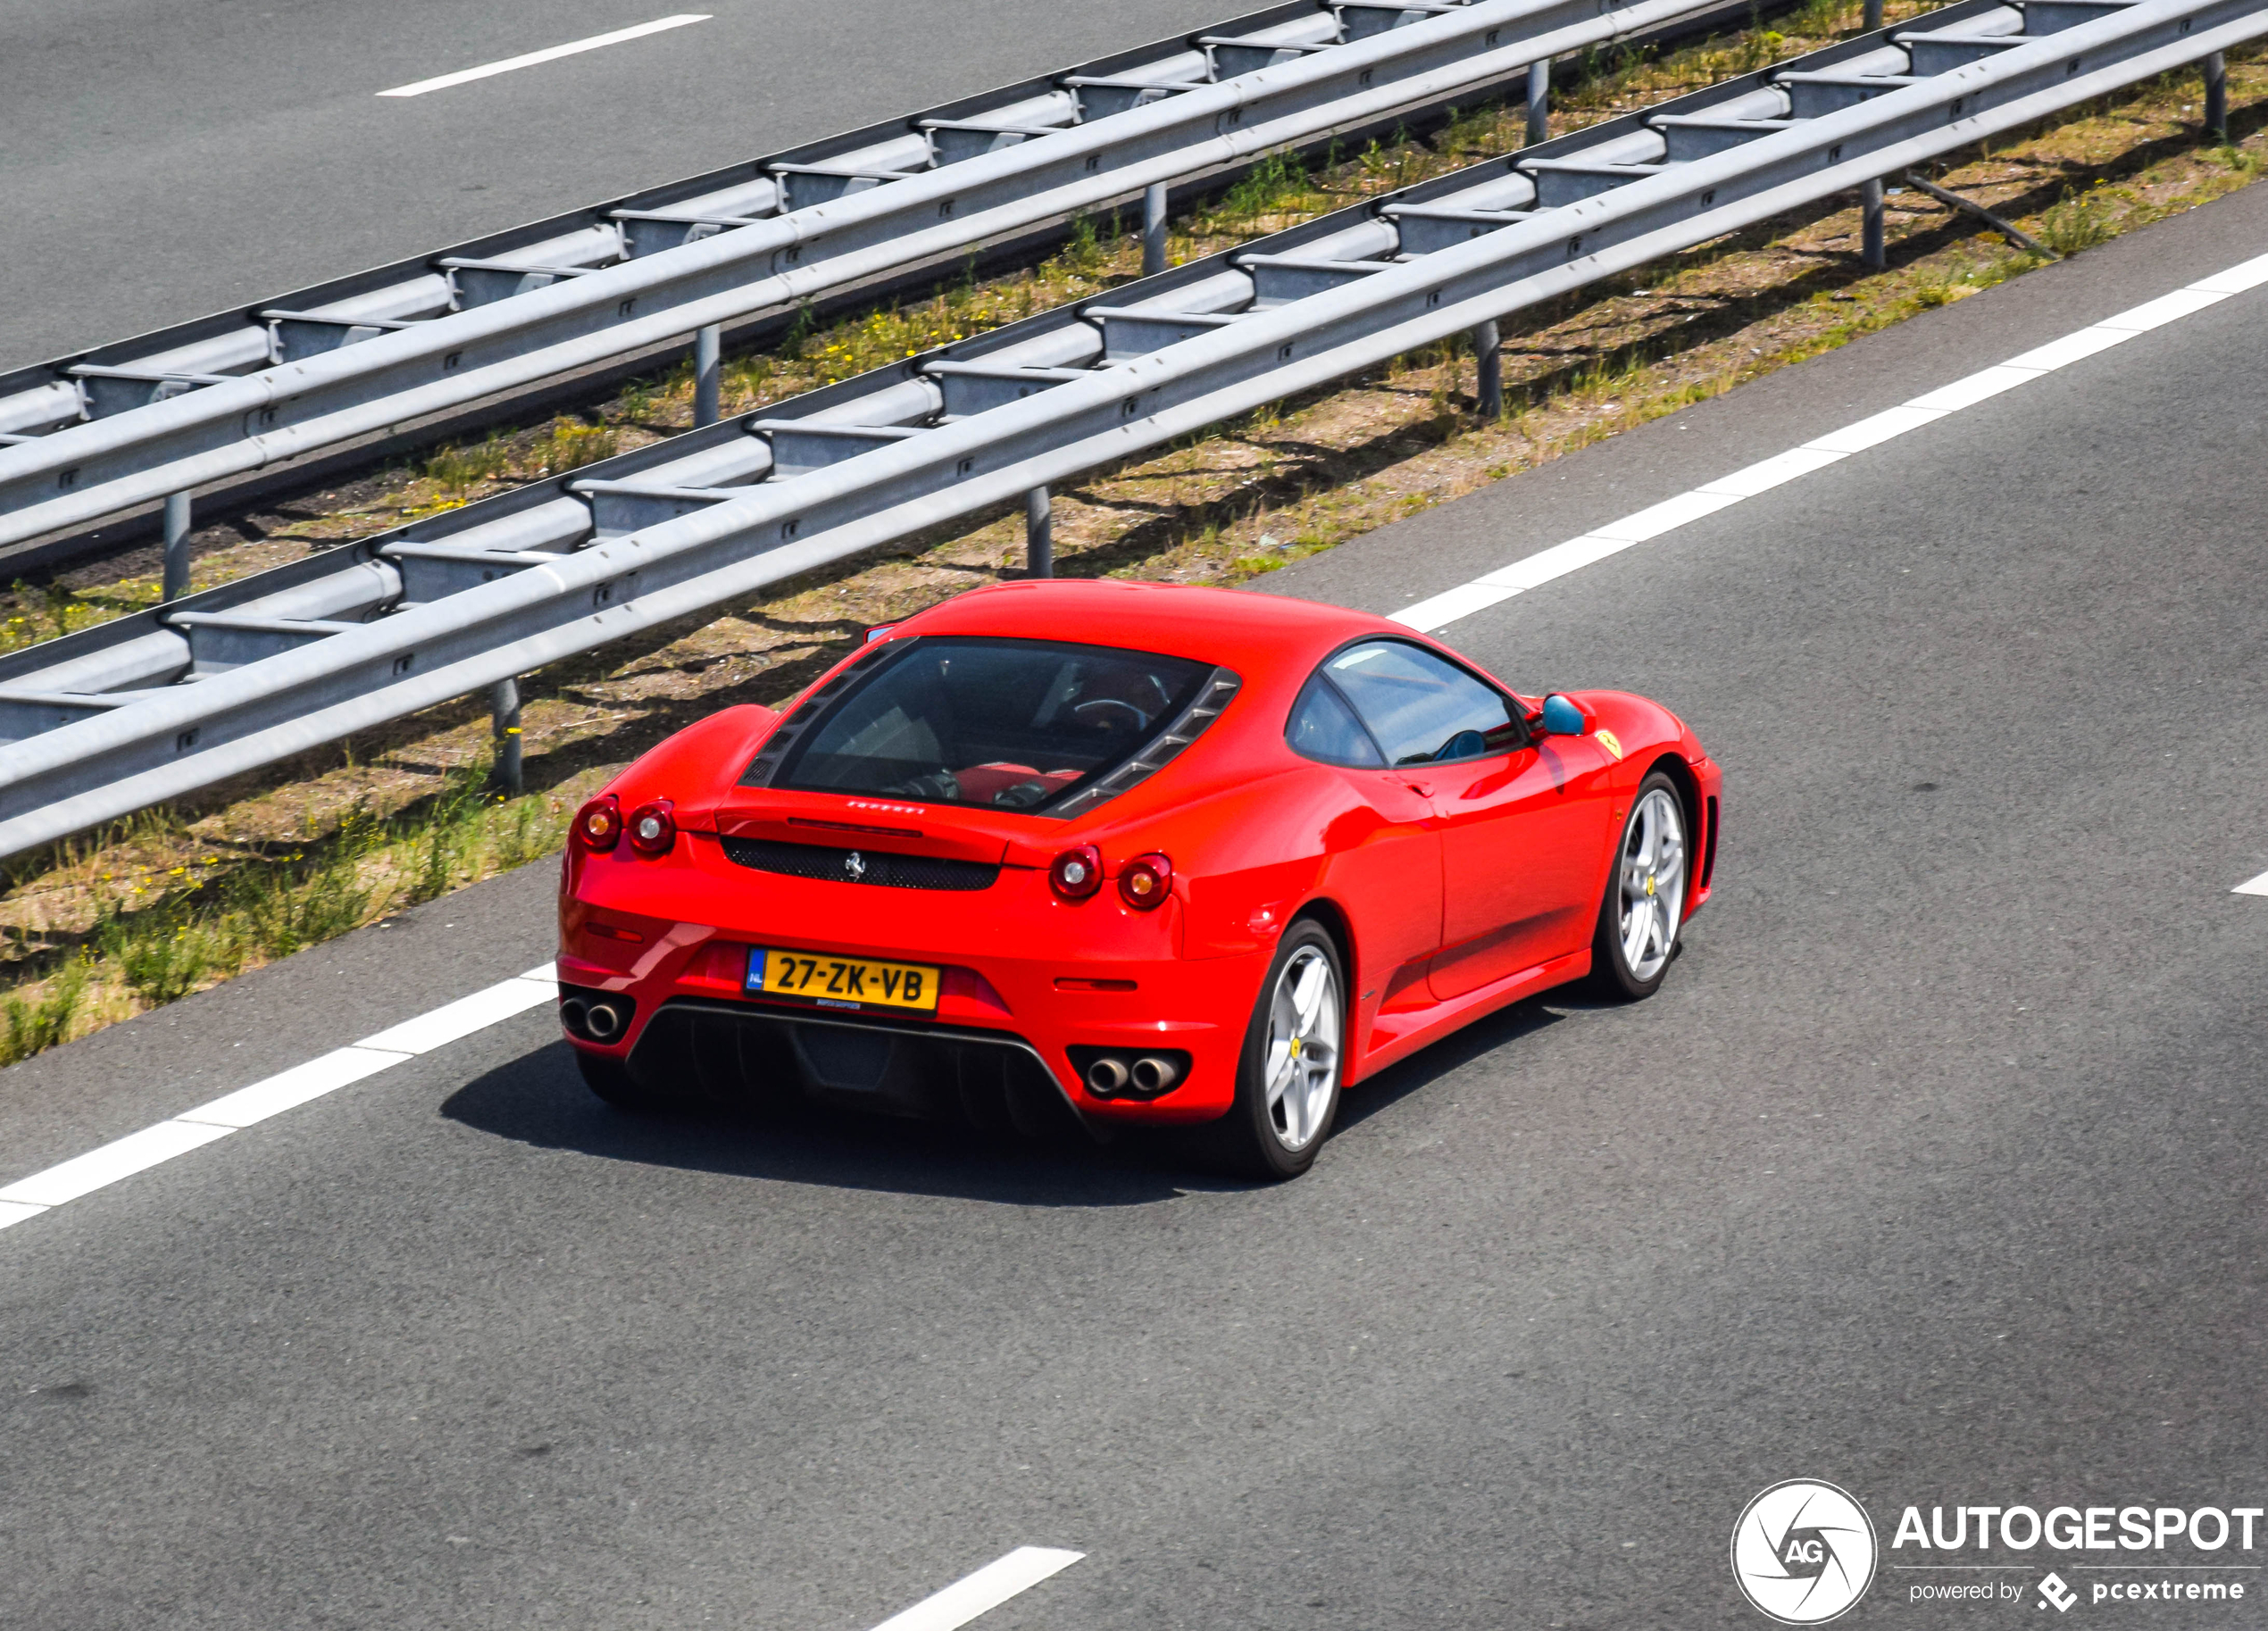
[1218,919,1347,1182]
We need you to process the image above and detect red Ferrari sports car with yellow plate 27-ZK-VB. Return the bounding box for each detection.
[558,581,1722,1177]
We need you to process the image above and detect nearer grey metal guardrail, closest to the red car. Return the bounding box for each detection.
[0,0,2240,855]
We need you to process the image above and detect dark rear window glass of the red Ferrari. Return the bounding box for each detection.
[773,637,1213,810]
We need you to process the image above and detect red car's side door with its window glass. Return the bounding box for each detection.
[1324,640,1605,1001]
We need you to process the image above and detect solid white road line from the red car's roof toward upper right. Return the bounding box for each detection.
[1393,254,2268,630]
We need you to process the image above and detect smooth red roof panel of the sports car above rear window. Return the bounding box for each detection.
[900,578,1411,671]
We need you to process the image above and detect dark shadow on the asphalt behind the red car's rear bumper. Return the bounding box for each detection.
[440,1041,1245,1207]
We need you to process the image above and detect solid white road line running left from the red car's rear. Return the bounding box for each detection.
[0,961,558,1229]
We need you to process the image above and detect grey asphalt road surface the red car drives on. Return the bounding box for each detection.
[0,186,2268,1631]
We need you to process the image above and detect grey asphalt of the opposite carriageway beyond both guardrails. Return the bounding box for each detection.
[0,0,1250,368]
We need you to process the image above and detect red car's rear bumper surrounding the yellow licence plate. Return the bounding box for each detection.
[558,835,1268,1123]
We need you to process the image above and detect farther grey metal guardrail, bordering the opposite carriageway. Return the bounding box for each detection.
[0,0,1726,558]
